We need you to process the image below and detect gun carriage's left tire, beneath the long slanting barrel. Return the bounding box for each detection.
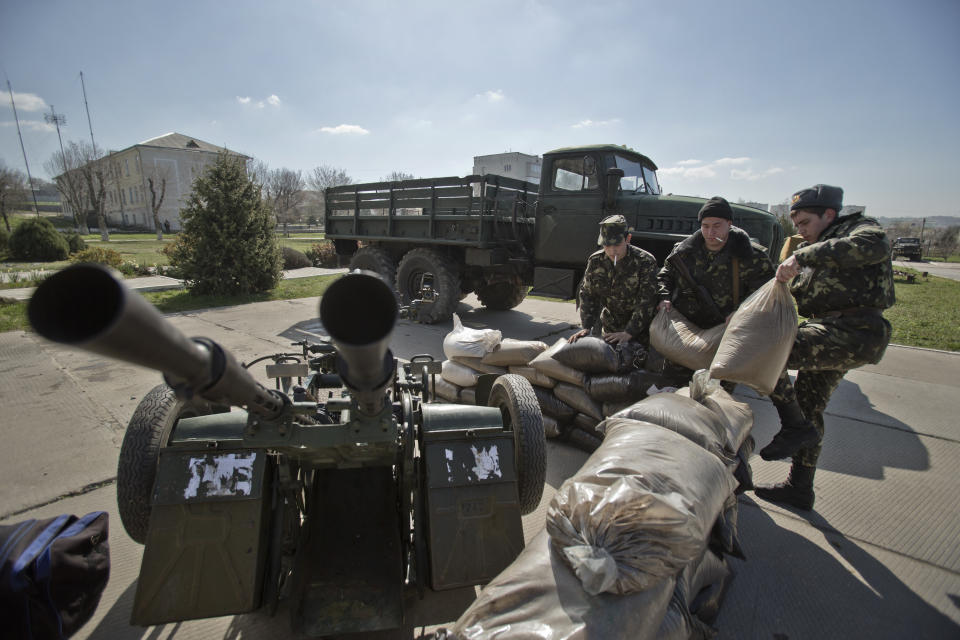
[117,384,214,544]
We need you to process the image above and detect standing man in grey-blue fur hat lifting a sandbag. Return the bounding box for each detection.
[754,184,894,511]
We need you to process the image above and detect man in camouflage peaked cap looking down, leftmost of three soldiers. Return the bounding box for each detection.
[570,215,657,345]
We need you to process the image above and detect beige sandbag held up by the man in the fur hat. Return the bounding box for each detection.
[710,278,798,395]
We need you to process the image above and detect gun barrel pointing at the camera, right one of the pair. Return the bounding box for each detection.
[320,271,397,415]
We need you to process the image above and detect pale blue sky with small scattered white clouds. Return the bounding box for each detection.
[0,0,960,216]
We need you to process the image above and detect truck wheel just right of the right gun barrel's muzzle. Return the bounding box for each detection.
[397,249,460,324]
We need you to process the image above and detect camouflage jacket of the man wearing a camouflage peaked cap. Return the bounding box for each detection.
[577,245,657,341]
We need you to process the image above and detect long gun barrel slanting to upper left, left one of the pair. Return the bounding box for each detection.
[27,264,282,415]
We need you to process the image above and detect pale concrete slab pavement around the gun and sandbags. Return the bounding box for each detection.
[0,297,960,640]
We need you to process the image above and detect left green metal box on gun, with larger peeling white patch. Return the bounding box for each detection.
[131,448,271,626]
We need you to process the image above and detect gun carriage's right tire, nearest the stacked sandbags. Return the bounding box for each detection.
[487,373,547,515]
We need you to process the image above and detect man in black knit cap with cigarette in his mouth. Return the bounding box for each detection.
[657,196,774,336]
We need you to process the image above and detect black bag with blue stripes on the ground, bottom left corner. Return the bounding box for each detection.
[0,511,110,640]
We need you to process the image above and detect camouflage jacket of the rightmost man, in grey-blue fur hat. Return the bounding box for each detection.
[790,213,895,318]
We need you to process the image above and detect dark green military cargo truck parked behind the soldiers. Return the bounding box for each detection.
[324,145,783,322]
